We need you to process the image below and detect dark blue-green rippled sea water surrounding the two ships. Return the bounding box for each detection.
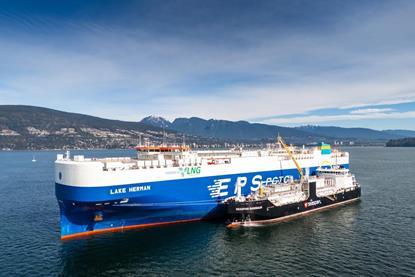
[0,147,415,276]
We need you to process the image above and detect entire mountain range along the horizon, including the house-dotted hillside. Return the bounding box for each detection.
[0,105,415,149]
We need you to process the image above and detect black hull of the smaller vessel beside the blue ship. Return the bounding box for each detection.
[226,182,361,227]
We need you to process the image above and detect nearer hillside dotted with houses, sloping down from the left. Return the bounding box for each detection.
[0,105,180,149]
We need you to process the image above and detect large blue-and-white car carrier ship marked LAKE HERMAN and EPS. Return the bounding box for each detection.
[55,137,349,239]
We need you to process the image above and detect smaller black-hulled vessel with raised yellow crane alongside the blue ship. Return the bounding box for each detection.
[224,137,361,228]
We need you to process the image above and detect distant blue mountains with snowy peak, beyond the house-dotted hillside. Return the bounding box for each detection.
[140,116,415,143]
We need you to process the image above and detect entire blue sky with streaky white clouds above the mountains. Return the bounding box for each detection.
[0,0,415,130]
